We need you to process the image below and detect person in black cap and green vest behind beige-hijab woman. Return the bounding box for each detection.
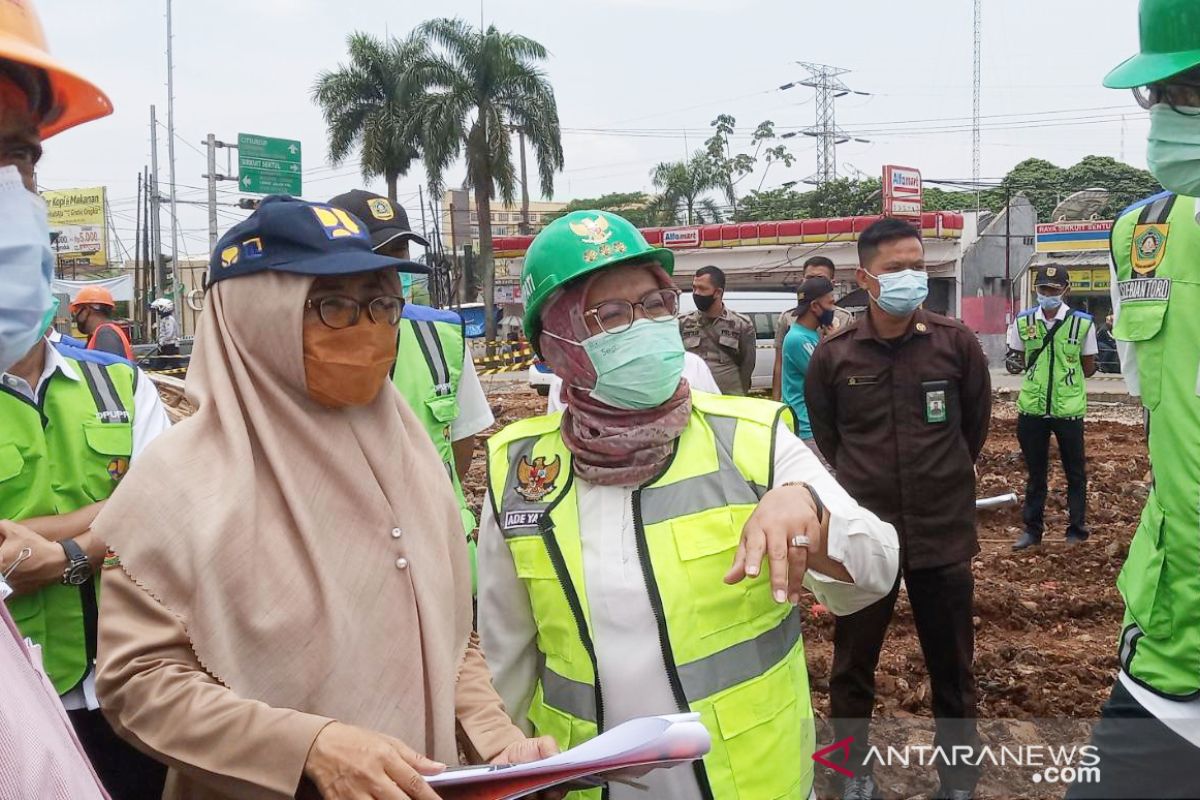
[329,190,496,587]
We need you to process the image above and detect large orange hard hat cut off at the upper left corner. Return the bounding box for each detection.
[0,0,113,139]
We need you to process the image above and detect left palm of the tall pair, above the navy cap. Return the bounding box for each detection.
[312,32,425,200]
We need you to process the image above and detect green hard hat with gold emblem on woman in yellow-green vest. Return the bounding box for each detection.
[521,211,674,344]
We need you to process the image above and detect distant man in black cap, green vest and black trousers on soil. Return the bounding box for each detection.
[1008,266,1099,551]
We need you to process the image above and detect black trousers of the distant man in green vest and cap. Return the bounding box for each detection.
[1016,414,1087,539]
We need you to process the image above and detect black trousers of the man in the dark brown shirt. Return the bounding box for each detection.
[829,561,979,790]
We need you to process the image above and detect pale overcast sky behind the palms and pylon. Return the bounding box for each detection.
[37,0,1147,258]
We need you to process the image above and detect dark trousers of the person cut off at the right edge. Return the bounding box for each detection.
[1067,680,1200,800]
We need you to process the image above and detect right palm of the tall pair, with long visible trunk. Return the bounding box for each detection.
[412,19,563,341]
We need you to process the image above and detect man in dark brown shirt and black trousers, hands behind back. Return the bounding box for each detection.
[805,218,991,800]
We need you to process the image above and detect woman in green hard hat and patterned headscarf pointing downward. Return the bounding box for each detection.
[479,211,898,800]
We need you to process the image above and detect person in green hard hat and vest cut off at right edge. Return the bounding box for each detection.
[1067,0,1200,798]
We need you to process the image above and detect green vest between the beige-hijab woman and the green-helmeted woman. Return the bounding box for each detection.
[391,303,476,588]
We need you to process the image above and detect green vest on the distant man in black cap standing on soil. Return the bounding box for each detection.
[1016,308,1092,419]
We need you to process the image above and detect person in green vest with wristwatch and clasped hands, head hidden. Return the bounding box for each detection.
[0,331,170,800]
